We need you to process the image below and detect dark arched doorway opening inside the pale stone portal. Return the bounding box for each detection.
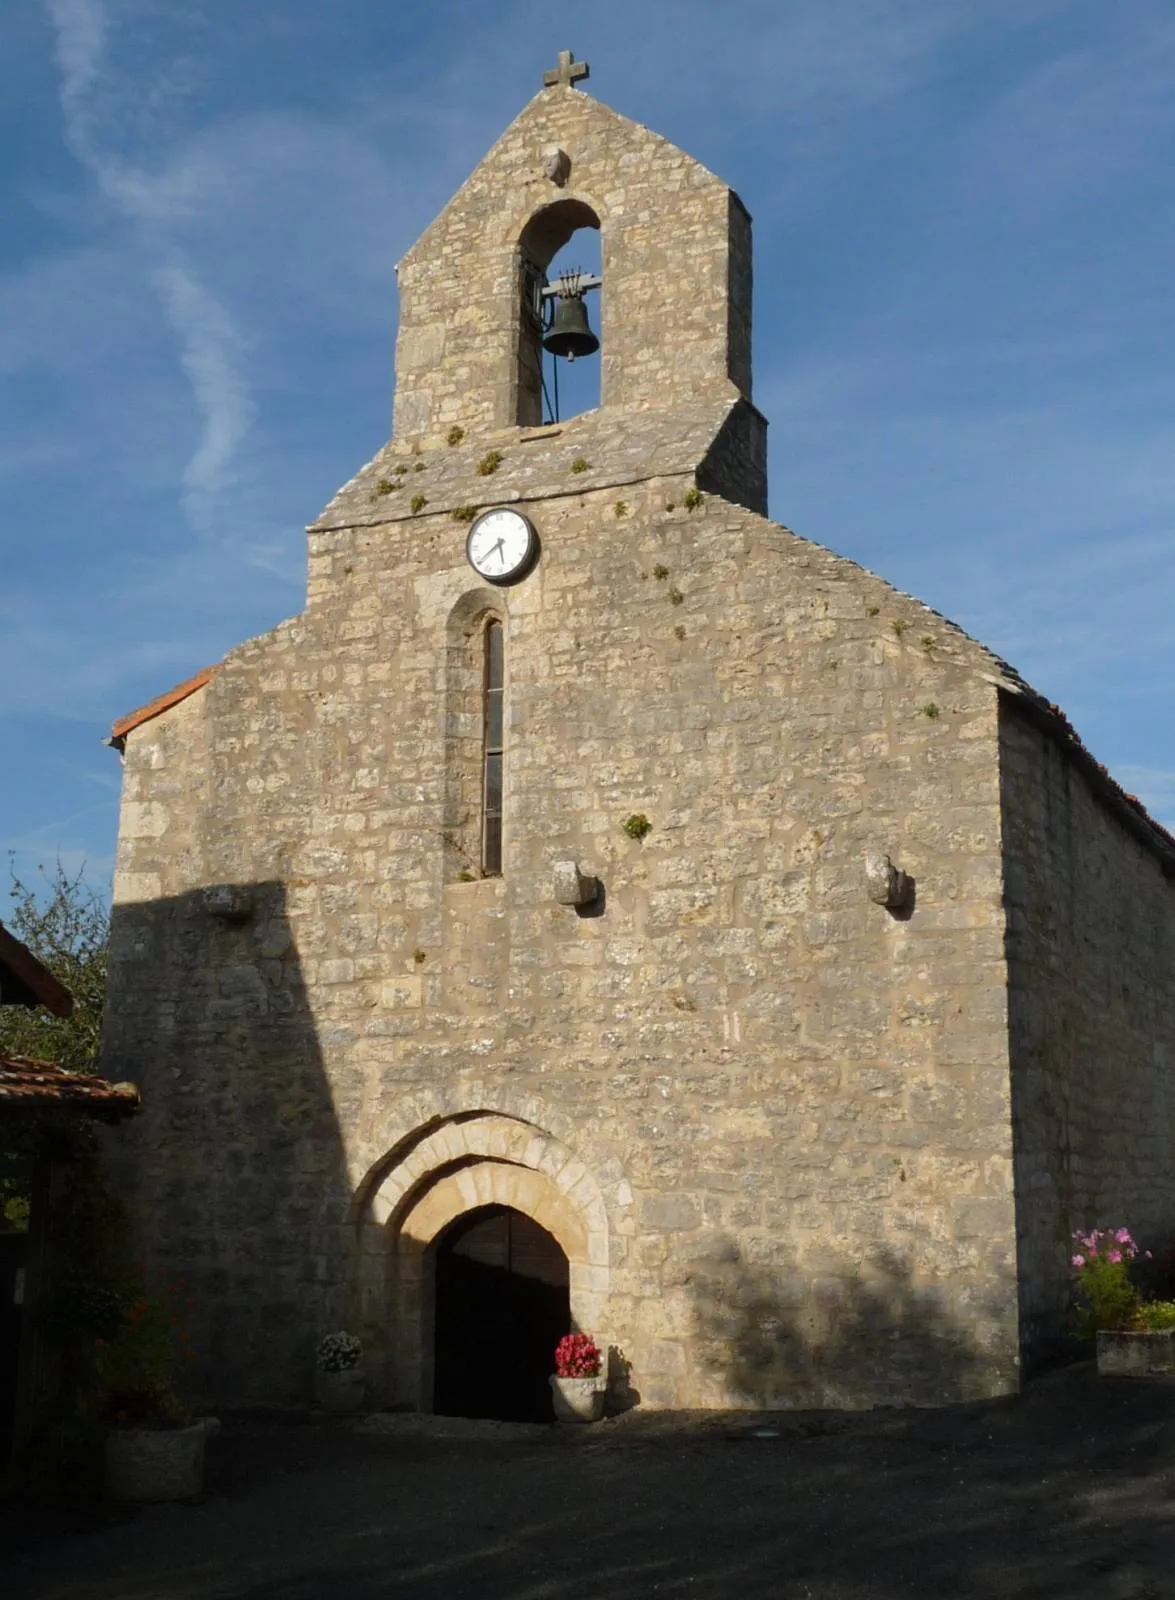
[432,1205,571,1422]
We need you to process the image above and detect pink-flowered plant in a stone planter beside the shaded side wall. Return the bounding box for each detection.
[1073,1227,1175,1378]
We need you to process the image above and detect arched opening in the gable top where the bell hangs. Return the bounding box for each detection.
[515,198,604,427]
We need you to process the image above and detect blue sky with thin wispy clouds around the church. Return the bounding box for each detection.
[0,0,1175,886]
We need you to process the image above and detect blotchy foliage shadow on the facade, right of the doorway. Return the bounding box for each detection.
[688,1238,1017,1410]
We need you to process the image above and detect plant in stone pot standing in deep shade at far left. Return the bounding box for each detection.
[93,1296,207,1501]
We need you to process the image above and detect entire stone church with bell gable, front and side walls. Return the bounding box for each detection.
[101,58,1175,1410]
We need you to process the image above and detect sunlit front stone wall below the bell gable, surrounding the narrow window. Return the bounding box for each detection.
[104,476,1024,1406]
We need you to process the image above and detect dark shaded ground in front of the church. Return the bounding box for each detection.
[0,1368,1175,1600]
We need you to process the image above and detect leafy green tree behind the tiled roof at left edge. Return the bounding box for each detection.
[0,861,110,1072]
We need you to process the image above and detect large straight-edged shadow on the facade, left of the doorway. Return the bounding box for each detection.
[101,882,359,1403]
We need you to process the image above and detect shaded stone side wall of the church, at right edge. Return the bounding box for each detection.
[1001,701,1175,1355]
